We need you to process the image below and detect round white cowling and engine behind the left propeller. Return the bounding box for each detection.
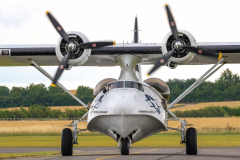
[55,31,91,66]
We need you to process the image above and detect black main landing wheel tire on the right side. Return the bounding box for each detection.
[186,128,197,155]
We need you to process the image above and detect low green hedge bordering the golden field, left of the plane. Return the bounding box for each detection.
[0,104,87,118]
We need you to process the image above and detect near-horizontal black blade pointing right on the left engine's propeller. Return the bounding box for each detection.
[77,41,116,49]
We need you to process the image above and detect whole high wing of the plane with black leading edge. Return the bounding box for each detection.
[0,42,240,66]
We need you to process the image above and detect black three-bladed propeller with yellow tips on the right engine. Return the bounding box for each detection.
[147,4,222,76]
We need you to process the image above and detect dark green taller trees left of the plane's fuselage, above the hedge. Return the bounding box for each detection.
[0,84,93,108]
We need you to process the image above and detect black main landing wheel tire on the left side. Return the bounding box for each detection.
[61,128,73,156]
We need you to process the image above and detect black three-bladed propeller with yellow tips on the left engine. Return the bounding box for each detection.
[46,11,116,87]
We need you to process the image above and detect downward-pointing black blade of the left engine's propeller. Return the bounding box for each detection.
[51,51,70,87]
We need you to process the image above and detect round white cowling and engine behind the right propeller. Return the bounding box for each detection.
[162,30,197,64]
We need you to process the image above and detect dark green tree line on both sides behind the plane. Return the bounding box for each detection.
[0,69,240,108]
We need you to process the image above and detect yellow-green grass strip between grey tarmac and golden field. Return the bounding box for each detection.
[0,134,240,148]
